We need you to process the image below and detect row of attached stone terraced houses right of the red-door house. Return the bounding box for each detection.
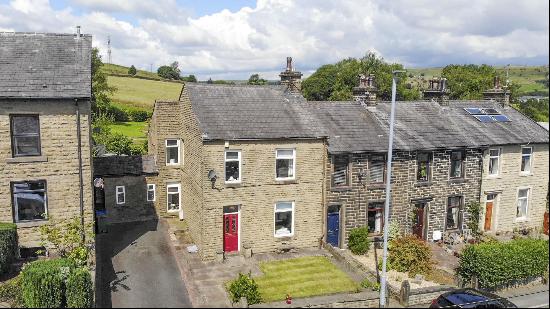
[309,76,548,247]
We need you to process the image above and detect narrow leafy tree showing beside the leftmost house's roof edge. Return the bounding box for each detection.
[92,47,116,116]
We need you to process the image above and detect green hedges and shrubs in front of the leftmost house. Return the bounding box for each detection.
[0,219,94,308]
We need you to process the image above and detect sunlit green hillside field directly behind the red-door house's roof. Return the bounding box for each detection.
[107,76,183,110]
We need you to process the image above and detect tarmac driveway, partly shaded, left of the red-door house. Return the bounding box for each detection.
[96,220,191,308]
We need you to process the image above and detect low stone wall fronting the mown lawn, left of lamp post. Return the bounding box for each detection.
[249,291,379,308]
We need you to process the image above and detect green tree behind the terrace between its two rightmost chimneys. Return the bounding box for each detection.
[441,64,497,100]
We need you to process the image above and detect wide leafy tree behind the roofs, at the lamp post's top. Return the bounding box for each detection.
[302,53,420,101]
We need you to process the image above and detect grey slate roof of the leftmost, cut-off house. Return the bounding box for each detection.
[0,32,92,98]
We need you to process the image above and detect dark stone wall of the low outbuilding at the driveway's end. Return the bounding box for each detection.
[103,176,158,224]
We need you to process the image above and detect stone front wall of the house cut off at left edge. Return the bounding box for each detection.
[0,99,94,247]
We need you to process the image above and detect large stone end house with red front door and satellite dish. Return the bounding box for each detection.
[149,60,326,260]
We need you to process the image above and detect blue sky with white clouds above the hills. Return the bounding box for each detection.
[0,0,549,80]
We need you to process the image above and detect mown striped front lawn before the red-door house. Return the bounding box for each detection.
[254,256,359,302]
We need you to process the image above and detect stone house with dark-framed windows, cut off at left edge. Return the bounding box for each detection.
[0,30,94,247]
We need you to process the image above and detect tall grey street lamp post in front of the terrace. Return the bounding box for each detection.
[380,71,405,307]
